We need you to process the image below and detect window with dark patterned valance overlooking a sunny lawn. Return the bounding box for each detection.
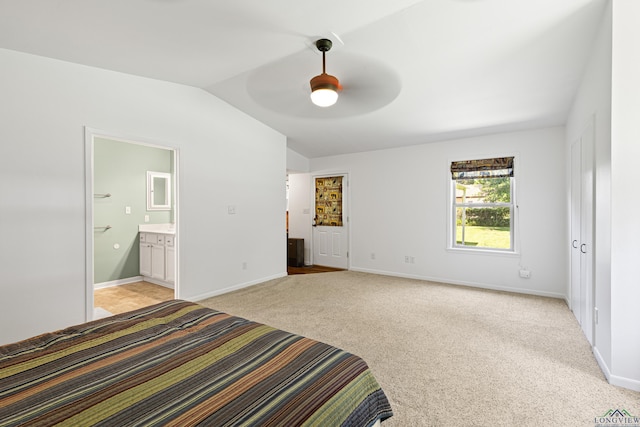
[451,157,515,252]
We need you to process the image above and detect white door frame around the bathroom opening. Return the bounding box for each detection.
[84,126,180,322]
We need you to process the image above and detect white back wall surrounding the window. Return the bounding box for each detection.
[302,127,567,298]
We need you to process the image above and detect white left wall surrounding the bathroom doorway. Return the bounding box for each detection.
[0,50,286,343]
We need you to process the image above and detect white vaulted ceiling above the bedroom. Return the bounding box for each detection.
[0,0,607,158]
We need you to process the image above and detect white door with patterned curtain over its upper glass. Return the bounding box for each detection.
[312,174,349,269]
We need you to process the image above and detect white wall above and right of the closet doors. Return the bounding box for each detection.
[566,0,611,378]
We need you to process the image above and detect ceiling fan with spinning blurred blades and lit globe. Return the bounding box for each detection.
[245,38,401,119]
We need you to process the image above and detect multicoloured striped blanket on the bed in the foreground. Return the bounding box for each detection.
[0,300,392,427]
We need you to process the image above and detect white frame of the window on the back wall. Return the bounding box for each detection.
[447,159,518,255]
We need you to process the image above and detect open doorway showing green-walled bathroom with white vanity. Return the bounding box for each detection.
[85,128,179,320]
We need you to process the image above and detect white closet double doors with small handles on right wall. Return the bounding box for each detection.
[571,121,595,345]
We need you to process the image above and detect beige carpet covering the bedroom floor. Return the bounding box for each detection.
[200,271,640,427]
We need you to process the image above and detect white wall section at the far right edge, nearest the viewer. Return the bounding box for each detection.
[611,0,640,391]
